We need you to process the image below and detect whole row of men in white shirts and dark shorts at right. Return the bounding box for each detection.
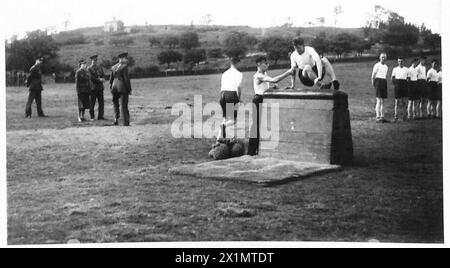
[372,53,442,123]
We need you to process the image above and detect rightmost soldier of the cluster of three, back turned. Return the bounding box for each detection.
[109,53,131,126]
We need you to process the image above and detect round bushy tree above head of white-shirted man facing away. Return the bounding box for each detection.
[223,31,258,57]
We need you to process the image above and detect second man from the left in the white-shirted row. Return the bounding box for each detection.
[391,57,409,121]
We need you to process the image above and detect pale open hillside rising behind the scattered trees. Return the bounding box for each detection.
[53,25,363,70]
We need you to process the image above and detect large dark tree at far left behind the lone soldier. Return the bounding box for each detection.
[6,30,59,73]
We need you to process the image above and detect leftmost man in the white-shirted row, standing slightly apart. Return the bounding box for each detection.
[372,53,389,123]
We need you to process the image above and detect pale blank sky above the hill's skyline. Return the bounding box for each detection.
[0,0,442,39]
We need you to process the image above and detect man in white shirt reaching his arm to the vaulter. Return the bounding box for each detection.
[248,57,293,155]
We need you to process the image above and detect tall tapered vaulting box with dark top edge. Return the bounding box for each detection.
[260,90,353,165]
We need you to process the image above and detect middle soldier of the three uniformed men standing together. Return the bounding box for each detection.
[88,55,105,120]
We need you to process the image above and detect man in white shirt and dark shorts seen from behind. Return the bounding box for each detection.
[217,57,243,139]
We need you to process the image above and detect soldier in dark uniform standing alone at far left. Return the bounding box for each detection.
[25,58,45,118]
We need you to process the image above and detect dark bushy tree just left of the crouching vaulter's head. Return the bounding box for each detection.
[258,36,291,64]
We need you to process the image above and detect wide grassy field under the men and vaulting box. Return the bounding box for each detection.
[6,60,443,244]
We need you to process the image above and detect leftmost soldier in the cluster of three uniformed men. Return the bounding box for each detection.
[75,59,91,122]
